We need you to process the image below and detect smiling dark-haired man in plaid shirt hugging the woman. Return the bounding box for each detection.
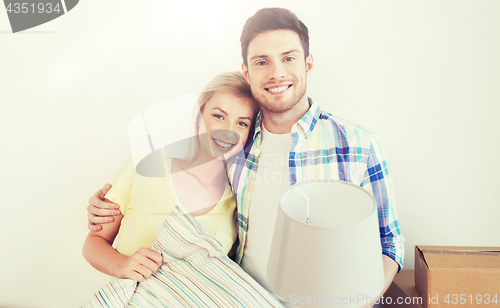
[89,8,404,308]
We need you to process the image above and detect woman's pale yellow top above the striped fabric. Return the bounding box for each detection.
[106,158,237,256]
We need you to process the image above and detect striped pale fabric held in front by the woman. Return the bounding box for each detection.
[83,206,283,308]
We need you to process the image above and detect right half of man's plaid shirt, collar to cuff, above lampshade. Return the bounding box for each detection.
[298,101,404,270]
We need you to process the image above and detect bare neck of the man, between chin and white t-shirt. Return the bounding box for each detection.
[262,95,309,134]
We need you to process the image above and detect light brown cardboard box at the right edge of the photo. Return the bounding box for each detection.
[415,245,500,308]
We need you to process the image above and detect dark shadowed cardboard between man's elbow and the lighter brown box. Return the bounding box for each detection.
[381,270,424,308]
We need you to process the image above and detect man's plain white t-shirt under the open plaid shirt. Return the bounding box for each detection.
[241,125,293,307]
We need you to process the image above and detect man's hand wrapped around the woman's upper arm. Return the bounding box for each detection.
[87,184,121,232]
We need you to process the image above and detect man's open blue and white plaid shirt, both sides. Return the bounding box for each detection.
[229,98,404,269]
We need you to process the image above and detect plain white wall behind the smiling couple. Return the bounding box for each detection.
[0,0,500,307]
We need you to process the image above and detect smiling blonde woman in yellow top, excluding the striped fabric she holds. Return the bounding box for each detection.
[83,72,258,281]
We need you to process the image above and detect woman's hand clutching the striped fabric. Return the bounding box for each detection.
[113,247,163,282]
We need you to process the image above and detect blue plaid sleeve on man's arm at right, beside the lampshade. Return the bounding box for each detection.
[361,135,404,270]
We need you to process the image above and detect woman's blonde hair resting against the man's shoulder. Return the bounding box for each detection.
[181,72,260,163]
